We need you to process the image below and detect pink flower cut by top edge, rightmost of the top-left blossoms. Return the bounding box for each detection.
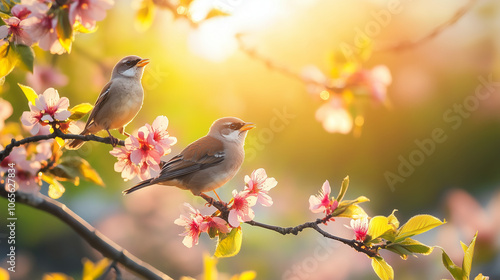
[69,0,114,30]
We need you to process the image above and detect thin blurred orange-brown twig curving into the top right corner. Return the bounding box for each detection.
[374,0,477,52]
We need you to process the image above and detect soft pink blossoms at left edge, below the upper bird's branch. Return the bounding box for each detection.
[0,145,41,192]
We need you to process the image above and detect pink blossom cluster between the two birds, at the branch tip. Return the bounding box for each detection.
[110,116,177,180]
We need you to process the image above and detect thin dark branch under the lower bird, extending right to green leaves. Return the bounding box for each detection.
[200,193,378,257]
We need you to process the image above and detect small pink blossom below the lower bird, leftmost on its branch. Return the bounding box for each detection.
[174,203,203,248]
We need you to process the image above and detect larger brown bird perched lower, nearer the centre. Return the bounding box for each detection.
[123,117,255,196]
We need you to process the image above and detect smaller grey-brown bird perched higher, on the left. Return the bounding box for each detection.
[66,55,149,150]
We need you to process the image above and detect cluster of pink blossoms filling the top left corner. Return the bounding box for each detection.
[0,0,114,54]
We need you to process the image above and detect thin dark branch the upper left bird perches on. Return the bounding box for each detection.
[0,129,125,162]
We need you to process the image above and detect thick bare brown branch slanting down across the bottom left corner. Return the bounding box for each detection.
[0,186,172,280]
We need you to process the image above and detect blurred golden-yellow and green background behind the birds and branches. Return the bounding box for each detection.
[0,0,500,279]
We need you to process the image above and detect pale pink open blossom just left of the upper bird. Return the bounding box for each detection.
[21,88,71,135]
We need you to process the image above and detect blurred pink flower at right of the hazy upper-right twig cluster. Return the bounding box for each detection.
[347,65,392,102]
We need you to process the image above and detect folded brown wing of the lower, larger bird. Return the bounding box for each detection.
[154,136,226,181]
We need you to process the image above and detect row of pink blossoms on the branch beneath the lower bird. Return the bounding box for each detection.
[174,168,278,248]
